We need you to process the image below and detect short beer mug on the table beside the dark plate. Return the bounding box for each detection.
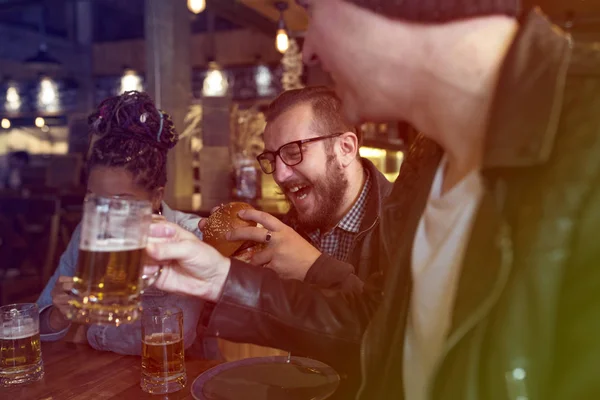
[141,306,187,394]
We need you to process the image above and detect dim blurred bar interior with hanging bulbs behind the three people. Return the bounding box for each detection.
[0,0,600,304]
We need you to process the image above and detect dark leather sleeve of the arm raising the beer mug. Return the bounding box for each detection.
[206,260,382,373]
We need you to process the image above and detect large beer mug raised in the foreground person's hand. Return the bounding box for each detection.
[67,195,160,326]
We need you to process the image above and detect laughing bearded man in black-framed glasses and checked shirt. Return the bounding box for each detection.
[212,86,392,290]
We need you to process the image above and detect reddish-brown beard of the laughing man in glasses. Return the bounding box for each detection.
[288,156,349,232]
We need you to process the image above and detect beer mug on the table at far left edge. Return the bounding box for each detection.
[0,303,44,386]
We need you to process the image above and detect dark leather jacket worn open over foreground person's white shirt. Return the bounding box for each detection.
[203,12,600,400]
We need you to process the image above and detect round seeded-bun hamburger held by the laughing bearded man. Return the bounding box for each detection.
[202,202,265,262]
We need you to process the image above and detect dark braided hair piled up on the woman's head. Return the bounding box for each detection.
[87,91,178,191]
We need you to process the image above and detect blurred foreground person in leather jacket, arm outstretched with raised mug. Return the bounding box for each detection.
[149,0,600,400]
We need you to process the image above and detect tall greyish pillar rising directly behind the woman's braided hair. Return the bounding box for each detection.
[145,0,194,210]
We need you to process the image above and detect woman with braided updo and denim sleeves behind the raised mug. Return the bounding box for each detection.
[37,92,216,355]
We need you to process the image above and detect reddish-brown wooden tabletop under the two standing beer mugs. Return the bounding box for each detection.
[0,341,219,400]
